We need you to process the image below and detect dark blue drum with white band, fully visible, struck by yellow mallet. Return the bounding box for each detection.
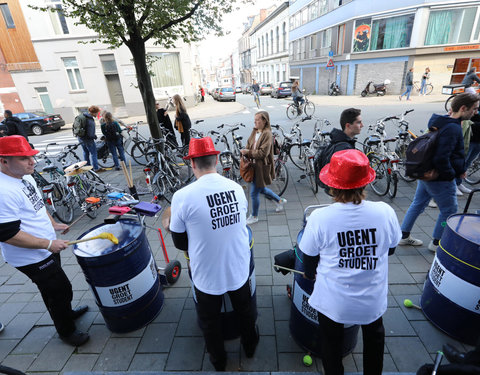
[73,219,164,333]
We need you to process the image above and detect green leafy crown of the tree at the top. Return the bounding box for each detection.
[32,0,234,48]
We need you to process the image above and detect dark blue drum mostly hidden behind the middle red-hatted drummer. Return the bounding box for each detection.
[188,226,257,340]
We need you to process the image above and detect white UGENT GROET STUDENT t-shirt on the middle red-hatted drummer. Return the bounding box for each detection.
[170,173,250,295]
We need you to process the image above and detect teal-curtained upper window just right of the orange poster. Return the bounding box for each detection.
[370,14,414,51]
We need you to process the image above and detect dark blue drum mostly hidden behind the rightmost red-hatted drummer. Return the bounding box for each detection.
[289,229,359,357]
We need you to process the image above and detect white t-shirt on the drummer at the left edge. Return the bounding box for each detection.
[0,172,56,267]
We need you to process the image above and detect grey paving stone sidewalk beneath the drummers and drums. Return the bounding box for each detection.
[0,166,480,374]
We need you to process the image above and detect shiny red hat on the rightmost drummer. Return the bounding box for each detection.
[320,150,375,190]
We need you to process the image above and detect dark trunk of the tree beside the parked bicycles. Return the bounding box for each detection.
[128,36,163,151]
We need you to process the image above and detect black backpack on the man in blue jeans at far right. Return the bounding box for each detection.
[405,128,438,180]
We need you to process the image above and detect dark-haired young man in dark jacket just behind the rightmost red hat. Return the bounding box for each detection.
[315,108,363,194]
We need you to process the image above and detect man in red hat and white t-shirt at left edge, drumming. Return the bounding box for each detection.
[0,135,89,346]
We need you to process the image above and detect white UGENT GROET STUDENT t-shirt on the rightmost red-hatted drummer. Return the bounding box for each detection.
[299,201,402,324]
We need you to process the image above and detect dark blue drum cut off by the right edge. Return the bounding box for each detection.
[421,214,480,345]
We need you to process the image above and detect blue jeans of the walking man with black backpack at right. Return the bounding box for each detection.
[402,180,458,240]
